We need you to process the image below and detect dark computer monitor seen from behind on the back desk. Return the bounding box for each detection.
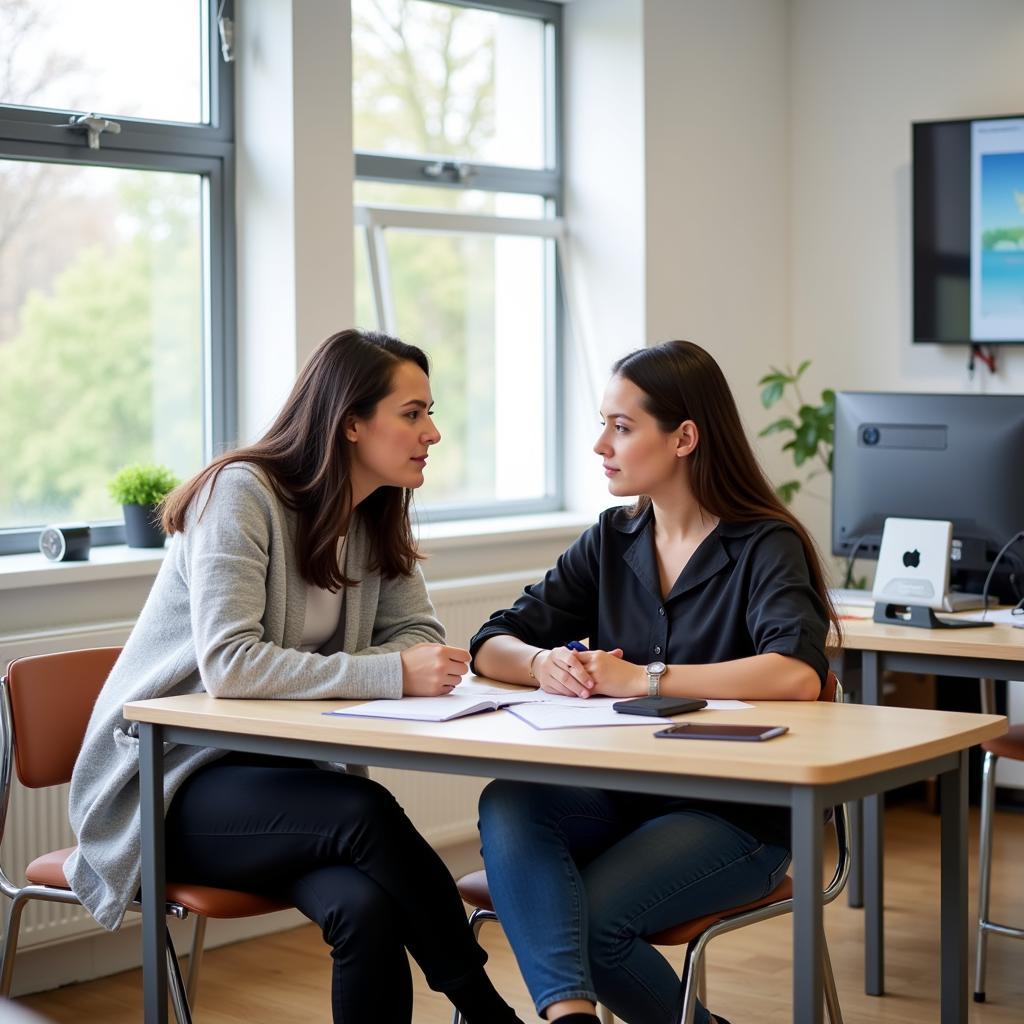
[831,391,1024,600]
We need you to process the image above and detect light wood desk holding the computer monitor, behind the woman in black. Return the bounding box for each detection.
[833,608,1024,995]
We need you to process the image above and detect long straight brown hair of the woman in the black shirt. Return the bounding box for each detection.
[611,341,842,640]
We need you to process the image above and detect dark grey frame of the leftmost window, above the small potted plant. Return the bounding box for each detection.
[0,0,238,555]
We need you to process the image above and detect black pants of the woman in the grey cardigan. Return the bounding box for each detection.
[167,754,486,1024]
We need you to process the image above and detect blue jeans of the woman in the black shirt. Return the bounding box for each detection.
[480,781,790,1024]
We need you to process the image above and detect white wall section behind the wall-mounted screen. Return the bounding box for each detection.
[790,0,1024,546]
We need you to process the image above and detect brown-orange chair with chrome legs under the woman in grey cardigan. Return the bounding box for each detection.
[0,647,288,1024]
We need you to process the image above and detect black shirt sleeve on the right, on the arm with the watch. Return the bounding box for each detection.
[746,524,828,681]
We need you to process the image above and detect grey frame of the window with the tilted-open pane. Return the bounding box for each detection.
[354,0,567,522]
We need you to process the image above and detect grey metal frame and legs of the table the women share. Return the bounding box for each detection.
[138,722,968,1024]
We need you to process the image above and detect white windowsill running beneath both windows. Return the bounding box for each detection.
[0,512,593,591]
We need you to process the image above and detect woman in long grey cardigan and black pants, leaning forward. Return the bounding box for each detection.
[66,330,517,1024]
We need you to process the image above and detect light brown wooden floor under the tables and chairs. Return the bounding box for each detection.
[20,806,1024,1024]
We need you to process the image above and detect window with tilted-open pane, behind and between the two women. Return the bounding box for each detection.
[352,0,564,519]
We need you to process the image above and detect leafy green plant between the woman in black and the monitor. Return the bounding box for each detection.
[758,359,836,505]
